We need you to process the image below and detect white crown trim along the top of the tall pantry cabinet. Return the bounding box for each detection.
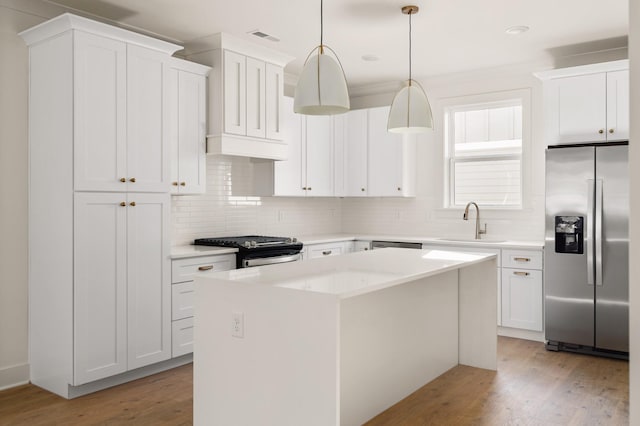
[19,13,182,55]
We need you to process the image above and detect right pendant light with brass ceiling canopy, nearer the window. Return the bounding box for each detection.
[387,6,433,133]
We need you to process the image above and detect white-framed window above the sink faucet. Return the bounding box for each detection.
[444,98,523,208]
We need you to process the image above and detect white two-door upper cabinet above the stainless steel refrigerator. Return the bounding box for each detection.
[536,60,629,145]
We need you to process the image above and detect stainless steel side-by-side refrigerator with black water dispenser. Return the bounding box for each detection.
[544,143,629,357]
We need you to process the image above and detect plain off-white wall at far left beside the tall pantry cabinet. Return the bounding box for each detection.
[0,0,68,389]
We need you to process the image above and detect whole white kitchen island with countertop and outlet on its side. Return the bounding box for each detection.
[194,248,497,426]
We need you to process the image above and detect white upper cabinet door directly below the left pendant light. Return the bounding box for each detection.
[305,115,334,196]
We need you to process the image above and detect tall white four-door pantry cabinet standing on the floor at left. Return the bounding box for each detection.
[20,14,201,398]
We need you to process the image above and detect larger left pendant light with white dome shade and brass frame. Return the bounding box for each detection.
[293,0,350,115]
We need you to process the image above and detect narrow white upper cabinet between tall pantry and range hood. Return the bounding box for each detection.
[164,58,210,195]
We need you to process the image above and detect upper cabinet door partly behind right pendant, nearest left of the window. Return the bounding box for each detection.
[368,107,403,197]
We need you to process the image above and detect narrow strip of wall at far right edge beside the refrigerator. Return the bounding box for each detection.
[629,0,640,425]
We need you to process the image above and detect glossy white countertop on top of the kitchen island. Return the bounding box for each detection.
[199,248,496,299]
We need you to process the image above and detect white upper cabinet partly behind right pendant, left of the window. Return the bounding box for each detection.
[344,107,416,197]
